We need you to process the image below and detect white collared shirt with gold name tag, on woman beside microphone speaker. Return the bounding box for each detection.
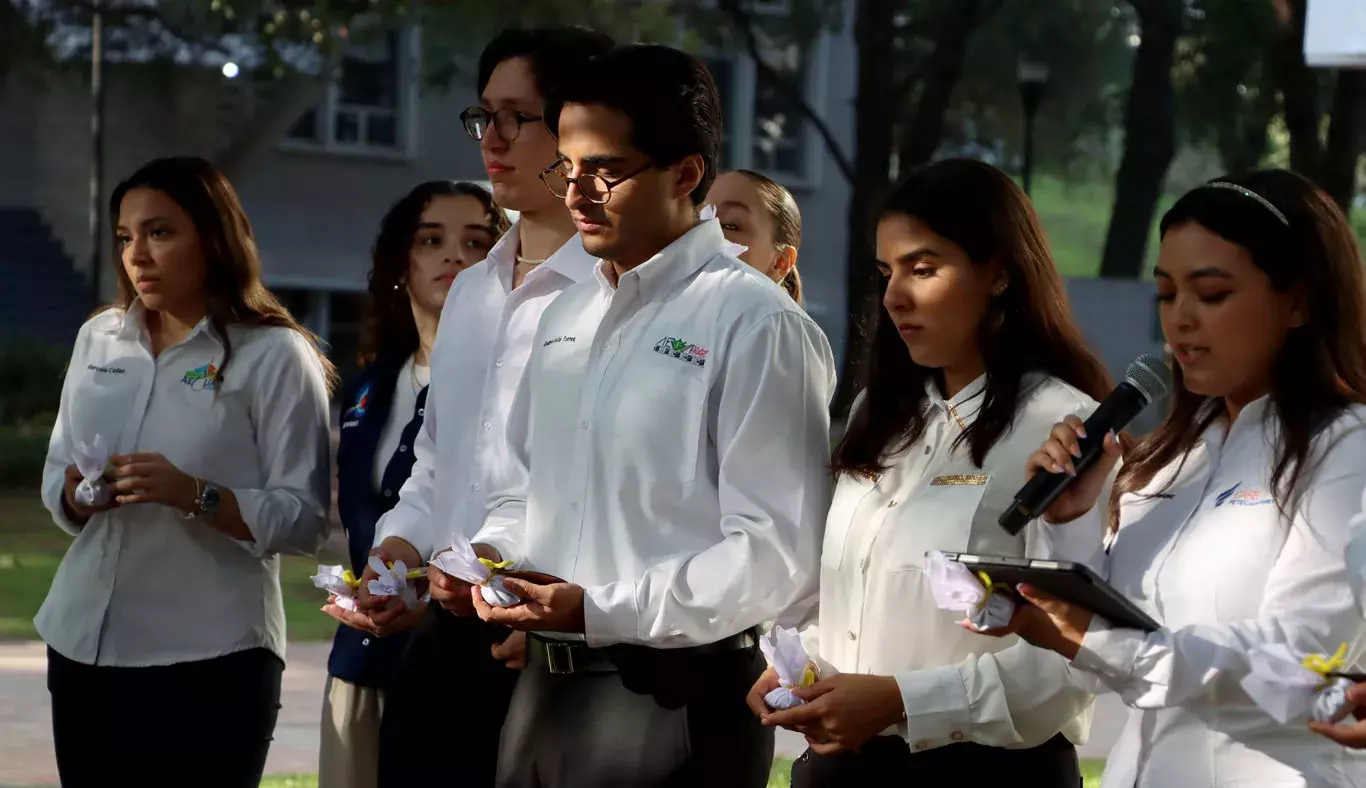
[803,374,1101,751]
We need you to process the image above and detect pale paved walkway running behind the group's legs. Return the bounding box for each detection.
[0,643,1123,785]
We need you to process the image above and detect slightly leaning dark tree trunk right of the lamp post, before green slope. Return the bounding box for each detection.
[1101,0,1183,279]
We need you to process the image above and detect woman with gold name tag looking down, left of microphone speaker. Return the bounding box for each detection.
[750,160,1111,788]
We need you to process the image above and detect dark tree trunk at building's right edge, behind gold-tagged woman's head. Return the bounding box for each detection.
[832,0,897,418]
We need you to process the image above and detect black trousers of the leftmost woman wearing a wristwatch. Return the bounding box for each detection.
[48,649,284,788]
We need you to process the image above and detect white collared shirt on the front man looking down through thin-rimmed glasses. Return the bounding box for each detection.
[475,220,835,647]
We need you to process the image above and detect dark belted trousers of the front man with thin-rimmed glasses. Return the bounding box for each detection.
[497,636,773,788]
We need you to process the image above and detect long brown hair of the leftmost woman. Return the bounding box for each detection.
[109,156,337,392]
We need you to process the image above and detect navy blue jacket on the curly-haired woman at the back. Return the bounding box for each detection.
[328,358,428,687]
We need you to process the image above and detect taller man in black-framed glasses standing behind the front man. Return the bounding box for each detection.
[330,27,612,788]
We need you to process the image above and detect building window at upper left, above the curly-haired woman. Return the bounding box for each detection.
[288,31,415,153]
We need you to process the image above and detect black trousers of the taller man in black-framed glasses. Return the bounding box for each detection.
[378,604,520,788]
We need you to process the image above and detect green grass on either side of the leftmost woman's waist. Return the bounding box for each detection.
[0,490,343,641]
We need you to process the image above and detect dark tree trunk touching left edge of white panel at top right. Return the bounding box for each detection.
[1273,0,1322,179]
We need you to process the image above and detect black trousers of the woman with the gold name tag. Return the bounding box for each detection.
[792,733,1082,788]
